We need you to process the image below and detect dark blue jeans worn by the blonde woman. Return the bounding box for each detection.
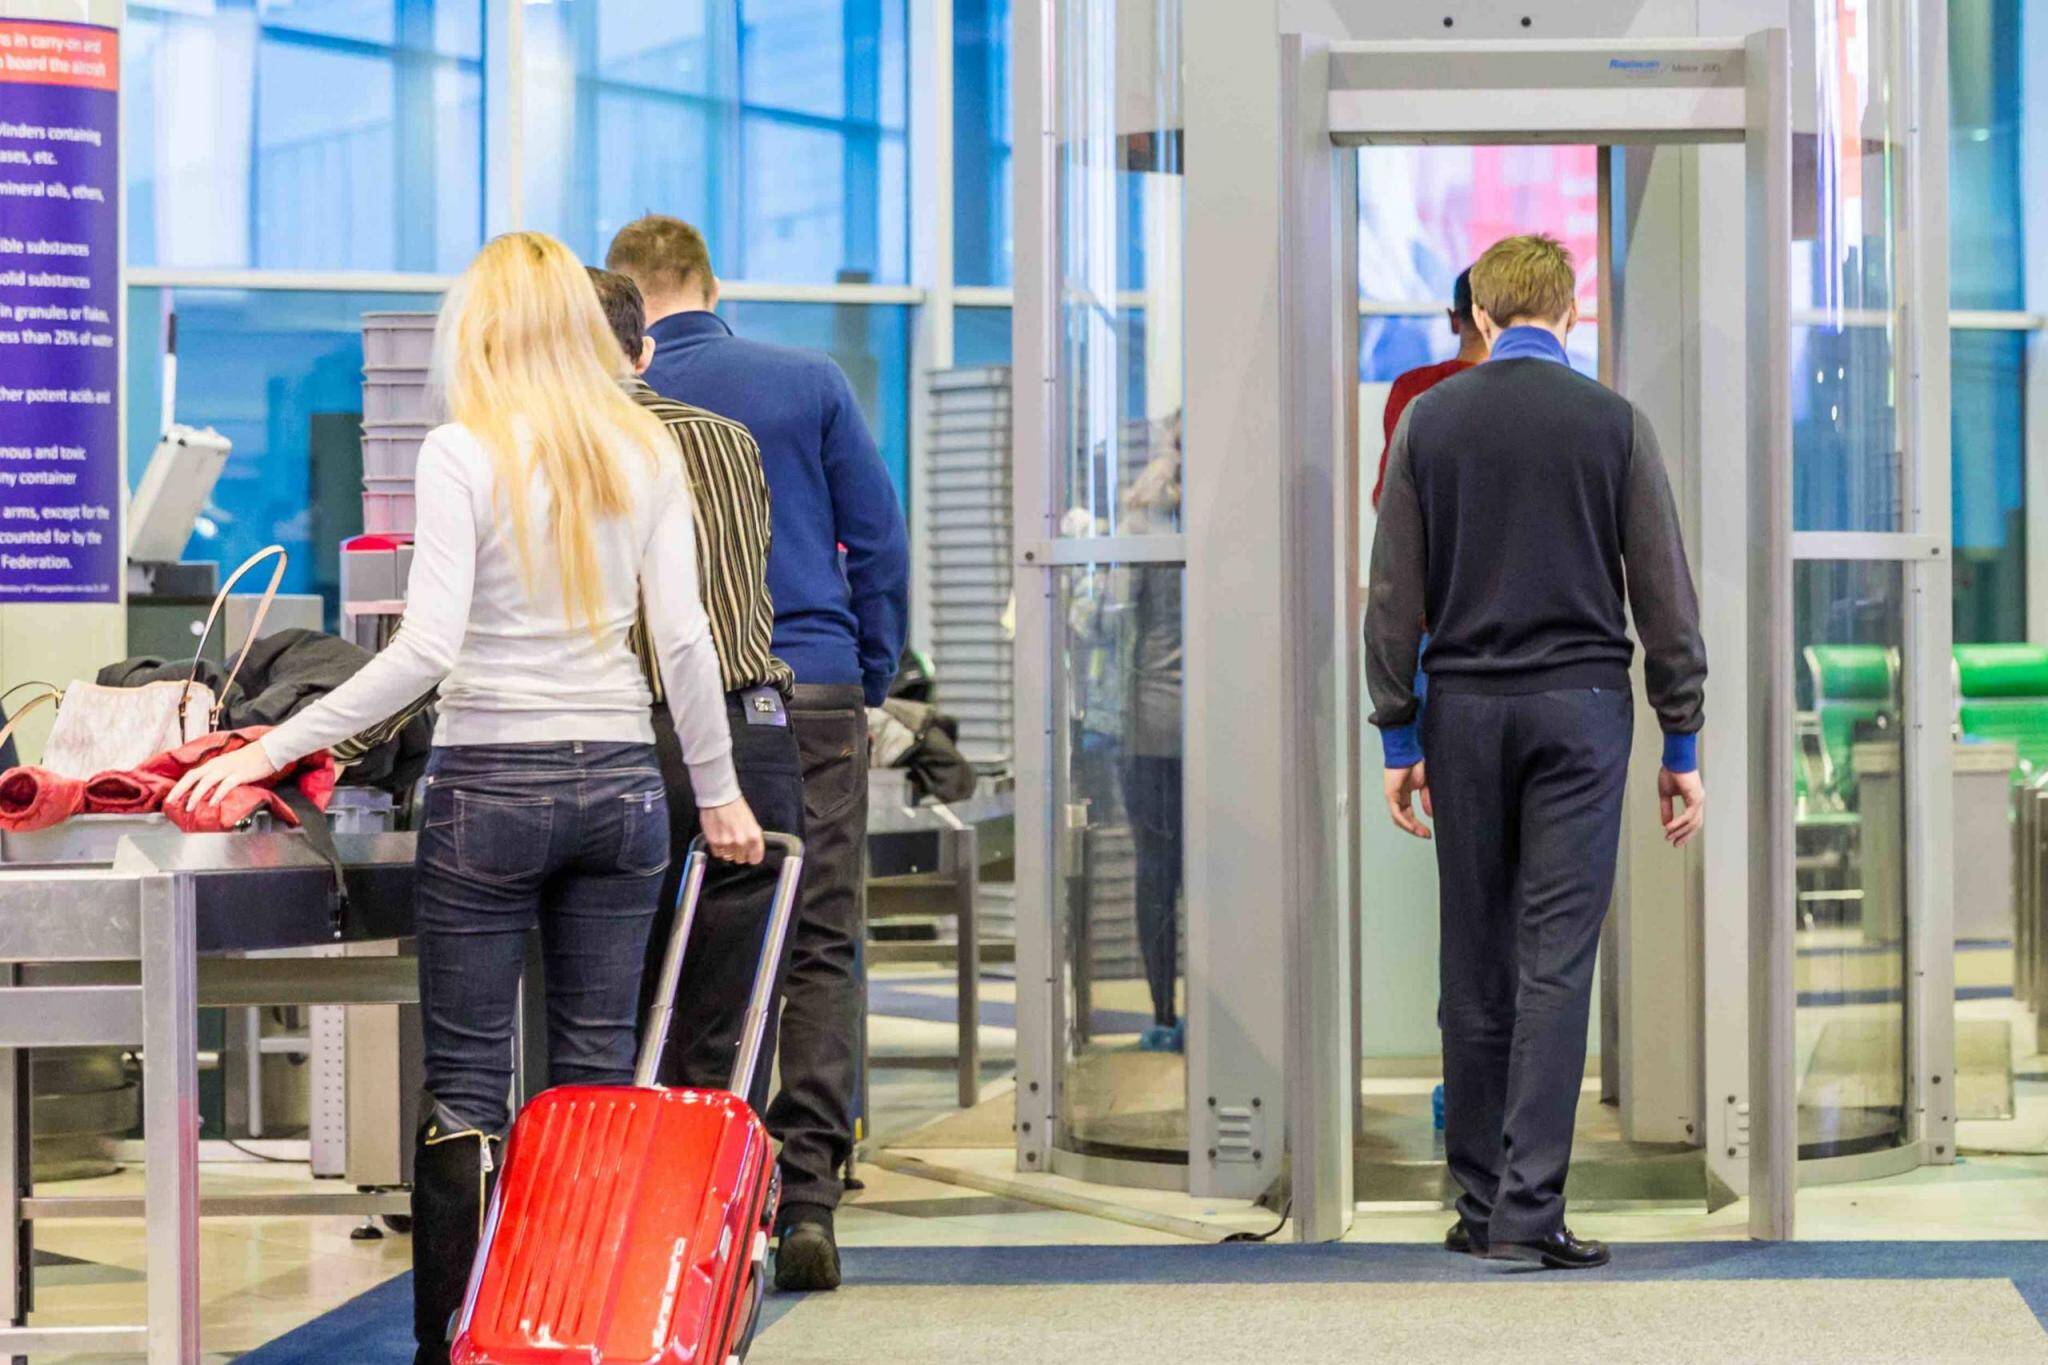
[416,741,668,1134]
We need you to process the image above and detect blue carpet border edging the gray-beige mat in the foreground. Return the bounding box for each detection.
[240,1242,2048,1365]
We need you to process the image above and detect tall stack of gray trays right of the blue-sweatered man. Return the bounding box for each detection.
[924,366,1016,765]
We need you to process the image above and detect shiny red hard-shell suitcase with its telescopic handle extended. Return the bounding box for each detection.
[453,835,803,1365]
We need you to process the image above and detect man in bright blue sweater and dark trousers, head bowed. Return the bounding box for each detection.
[604,215,909,1289]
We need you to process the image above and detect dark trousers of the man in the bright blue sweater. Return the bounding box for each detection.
[768,684,868,1207]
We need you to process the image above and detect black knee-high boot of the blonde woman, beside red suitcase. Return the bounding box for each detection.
[412,1095,504,1365]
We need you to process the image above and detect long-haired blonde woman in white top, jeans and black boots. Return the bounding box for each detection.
[172,233,762,1365]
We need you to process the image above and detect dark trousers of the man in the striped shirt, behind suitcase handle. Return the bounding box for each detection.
[641,690,803,1109]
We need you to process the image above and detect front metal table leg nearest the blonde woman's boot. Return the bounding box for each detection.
[141,876,199,1365]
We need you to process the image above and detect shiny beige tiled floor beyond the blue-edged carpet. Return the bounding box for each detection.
[24,965,2048,1365]
